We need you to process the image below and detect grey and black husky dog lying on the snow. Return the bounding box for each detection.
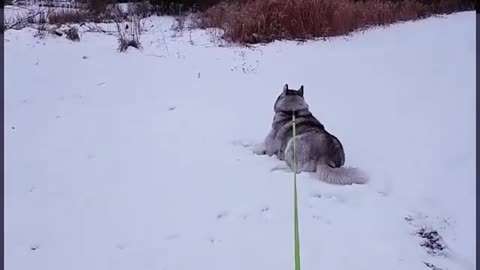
[254,84,368,185]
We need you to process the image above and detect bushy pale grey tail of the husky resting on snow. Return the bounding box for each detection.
[316,164,369,185]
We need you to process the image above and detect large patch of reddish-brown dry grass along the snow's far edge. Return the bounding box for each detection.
[200,0,476,43]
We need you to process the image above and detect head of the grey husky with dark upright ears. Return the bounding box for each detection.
[273,84,308,112]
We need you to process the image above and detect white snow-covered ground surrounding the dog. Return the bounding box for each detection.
[5,9,476,270]
